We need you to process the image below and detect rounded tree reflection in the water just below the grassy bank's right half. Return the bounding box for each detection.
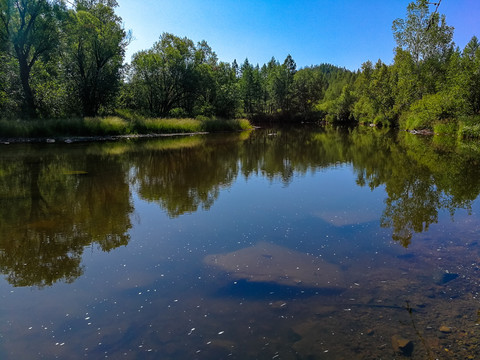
[131,135,241,217]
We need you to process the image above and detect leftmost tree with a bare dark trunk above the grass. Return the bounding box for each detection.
[0,0,62,117]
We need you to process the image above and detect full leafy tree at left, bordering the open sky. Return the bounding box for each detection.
[65,0,130,116]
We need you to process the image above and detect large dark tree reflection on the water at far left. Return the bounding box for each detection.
[0,150,133,287]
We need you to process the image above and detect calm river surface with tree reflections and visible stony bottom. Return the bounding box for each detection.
[0,128,480,359]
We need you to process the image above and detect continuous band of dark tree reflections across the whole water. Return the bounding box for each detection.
[0,128,480,287]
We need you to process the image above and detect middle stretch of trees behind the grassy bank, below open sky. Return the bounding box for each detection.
[121,37,346,118]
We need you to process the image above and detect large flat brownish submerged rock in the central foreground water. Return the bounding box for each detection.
[204,242,345,288]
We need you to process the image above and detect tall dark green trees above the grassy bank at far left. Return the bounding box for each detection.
[0,0,129,118]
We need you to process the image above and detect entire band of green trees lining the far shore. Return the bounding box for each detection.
[0,0,480,137]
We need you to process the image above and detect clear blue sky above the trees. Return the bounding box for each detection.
[117,0,480,70]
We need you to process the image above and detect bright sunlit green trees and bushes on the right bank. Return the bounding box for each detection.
[332,0,480,136]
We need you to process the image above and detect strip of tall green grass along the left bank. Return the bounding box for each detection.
[0,112,253,138]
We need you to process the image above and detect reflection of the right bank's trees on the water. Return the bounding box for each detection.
[352,130,480,247]
